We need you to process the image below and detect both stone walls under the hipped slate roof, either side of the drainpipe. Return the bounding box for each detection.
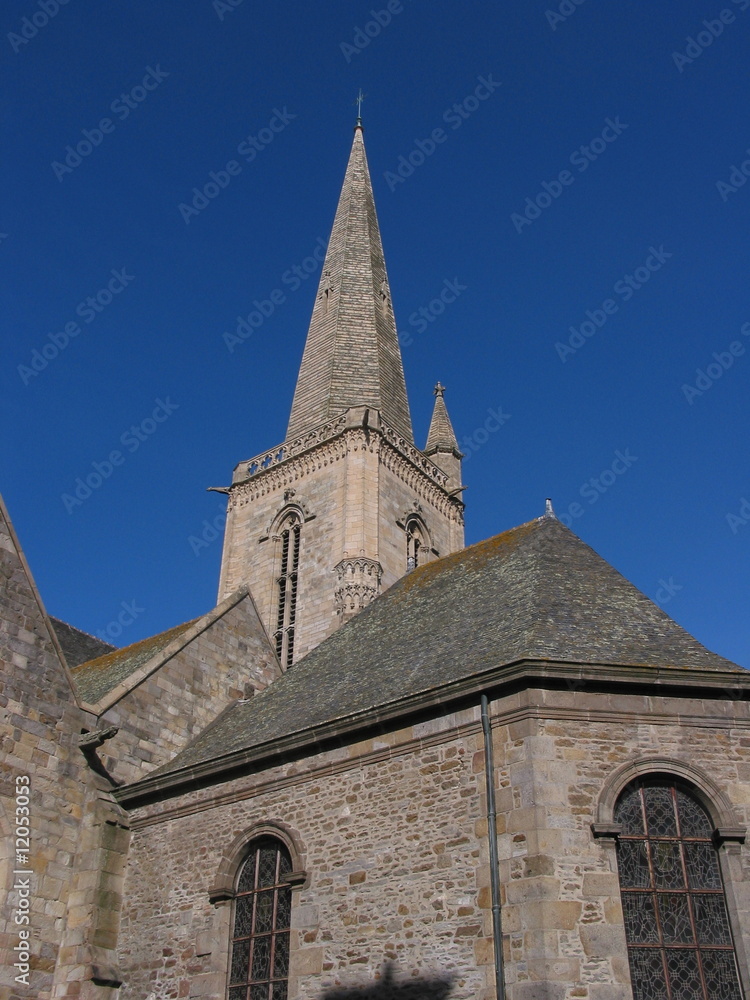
[120,691,750,1000]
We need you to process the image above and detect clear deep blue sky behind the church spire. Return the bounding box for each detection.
[0,0,750,666]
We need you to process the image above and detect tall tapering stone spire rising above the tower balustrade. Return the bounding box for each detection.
[287,119,414,444]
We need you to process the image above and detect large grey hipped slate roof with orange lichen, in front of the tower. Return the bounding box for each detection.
[152,515,744,775]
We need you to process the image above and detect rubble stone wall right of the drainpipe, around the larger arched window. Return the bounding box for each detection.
[493,690,750,1000]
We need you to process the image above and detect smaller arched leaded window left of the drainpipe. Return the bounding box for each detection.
[228,837,292,1000]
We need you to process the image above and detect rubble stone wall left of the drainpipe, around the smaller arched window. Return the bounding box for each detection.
[116,712,500,1000]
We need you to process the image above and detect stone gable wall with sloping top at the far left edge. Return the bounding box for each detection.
[0,510,121,1000]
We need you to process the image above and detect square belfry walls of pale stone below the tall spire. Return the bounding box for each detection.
[219,407,463,661]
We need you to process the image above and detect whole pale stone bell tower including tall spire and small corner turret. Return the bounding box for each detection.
[219,120,464,667]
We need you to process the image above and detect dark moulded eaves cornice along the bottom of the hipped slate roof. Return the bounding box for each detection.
[113,660,750,808]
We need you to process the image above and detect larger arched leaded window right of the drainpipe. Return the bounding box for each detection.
[614,777,742,1000]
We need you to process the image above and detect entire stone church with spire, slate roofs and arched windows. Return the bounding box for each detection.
[0,120,750,1000]
